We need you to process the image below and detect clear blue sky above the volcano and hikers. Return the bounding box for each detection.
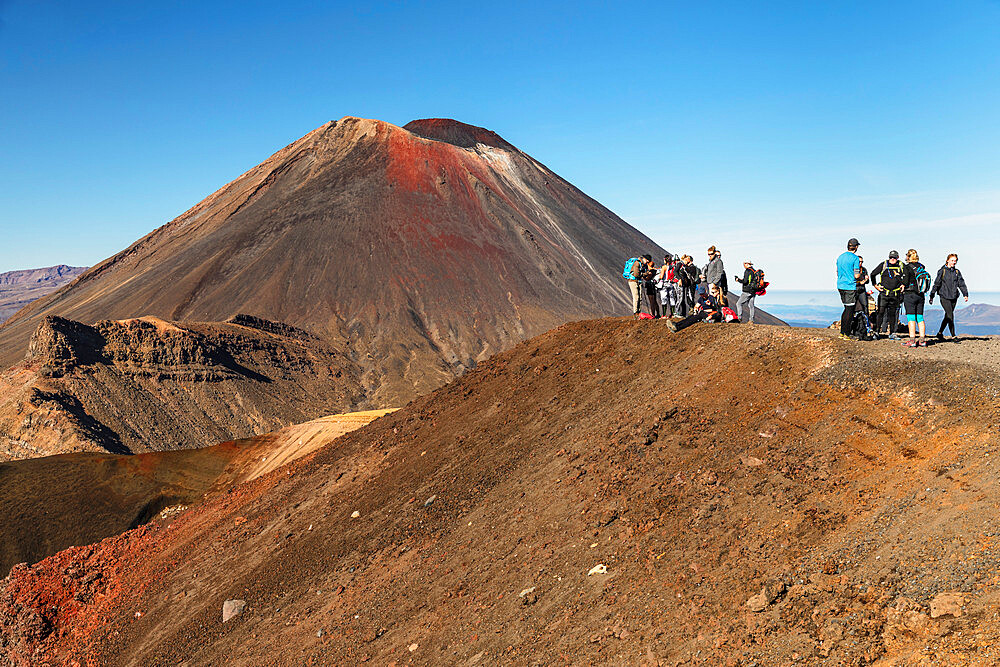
[0,0,1000,290]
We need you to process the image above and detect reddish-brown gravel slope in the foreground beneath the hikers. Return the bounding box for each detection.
[0,319,1000,665]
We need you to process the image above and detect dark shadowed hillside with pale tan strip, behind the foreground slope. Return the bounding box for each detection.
[0,410,388,574]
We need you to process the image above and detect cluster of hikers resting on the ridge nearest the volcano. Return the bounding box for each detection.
[622,246,768,331]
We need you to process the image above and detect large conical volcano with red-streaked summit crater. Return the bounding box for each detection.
[0,117,659,405]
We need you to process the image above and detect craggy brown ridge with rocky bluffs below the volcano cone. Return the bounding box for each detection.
[0,315,364,460]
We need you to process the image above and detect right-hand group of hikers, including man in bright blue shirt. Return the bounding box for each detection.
[837,238,969,347]
